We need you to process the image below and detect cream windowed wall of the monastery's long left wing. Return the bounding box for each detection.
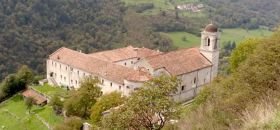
[47,60,135,96]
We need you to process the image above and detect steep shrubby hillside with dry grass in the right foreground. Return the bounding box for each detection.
[177,27,280,130]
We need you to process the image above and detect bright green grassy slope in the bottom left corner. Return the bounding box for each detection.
[0,95,62,130]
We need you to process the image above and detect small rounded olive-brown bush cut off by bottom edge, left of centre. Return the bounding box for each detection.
[54,117,83,130]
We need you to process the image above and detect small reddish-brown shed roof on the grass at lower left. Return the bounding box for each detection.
[22,89,47,104]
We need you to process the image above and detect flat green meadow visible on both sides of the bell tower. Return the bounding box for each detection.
[161,28,272,48]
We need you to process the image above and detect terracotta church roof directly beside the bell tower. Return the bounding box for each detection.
[146,48,212,75]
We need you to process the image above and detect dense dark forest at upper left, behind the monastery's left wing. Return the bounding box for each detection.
[0,0,173,79]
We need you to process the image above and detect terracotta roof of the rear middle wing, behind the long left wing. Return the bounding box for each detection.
[90,46,161,62]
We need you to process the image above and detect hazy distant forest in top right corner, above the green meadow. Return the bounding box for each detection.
[201,0,280,29]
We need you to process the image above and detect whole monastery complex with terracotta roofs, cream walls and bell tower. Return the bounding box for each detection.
[46,24,220,101]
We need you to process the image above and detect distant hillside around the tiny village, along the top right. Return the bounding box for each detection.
[123,0,280,29]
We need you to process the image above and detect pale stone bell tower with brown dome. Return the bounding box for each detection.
[200,23,220,80]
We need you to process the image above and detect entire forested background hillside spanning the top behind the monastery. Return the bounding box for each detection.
[0,0,280,80]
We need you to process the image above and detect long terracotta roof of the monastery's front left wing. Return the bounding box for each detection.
[49,47,152,84]
